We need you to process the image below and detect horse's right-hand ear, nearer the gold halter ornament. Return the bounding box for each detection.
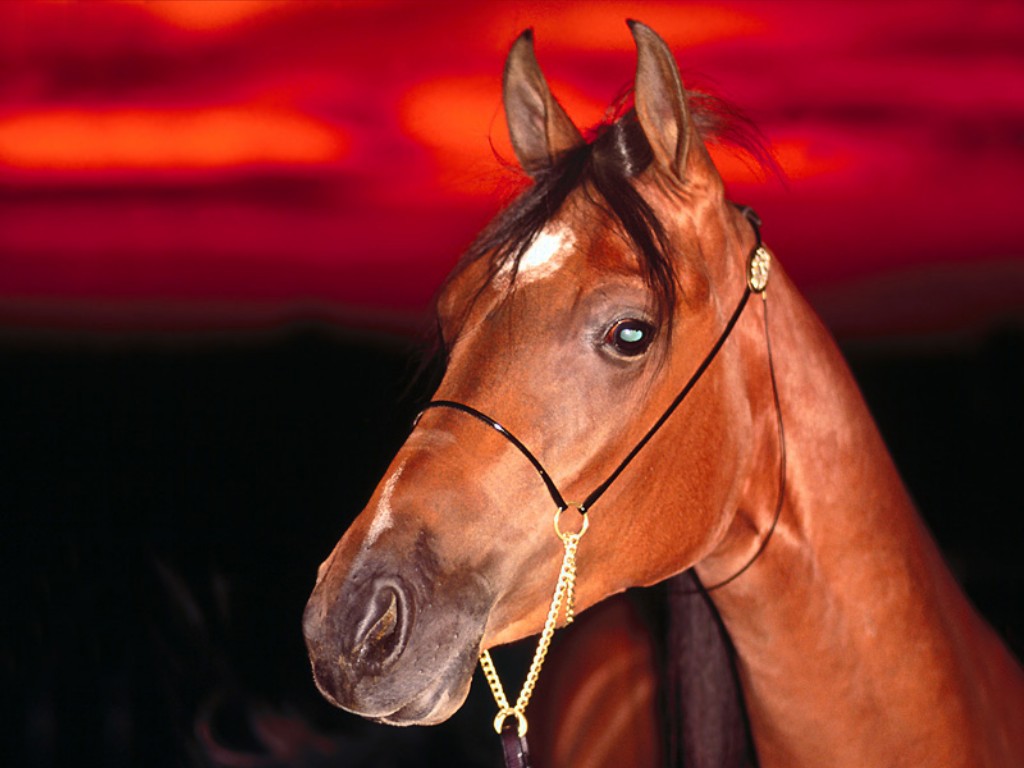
[627,19,711,181]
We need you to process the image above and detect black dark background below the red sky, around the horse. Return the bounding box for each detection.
[0,326,1024,766]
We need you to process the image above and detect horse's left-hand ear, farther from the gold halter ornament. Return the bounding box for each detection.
[503,30,583,176]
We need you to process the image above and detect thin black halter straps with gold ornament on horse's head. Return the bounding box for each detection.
[416,206,785,591]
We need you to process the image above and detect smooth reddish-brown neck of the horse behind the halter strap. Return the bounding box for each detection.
[698,264,1024,766]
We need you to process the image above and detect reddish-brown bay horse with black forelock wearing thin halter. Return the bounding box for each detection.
[303,22,1024,768]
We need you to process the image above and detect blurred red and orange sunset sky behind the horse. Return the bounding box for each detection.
[0,0,1024,335]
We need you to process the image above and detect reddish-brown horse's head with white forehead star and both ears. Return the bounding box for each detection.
[304,23,775,724]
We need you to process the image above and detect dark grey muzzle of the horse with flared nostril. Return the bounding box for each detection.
[302,537,492,725]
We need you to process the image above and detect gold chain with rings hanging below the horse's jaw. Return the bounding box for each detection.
[480,504,590,736]
